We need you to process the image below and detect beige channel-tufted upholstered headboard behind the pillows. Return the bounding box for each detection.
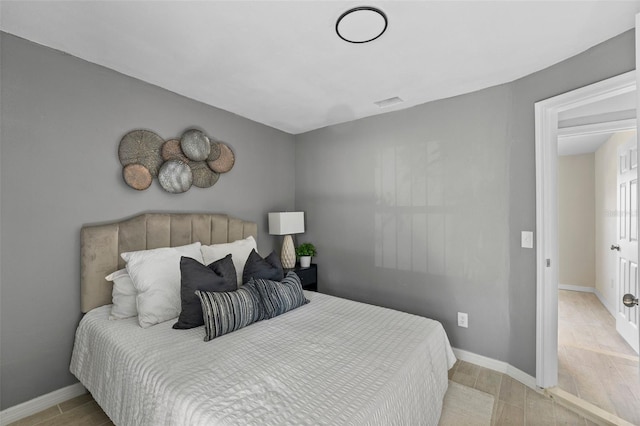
[80,213,258,312]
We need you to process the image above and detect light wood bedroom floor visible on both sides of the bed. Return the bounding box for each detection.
[10,361,595,426]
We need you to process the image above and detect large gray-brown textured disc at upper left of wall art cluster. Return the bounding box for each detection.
[118,130,164,176]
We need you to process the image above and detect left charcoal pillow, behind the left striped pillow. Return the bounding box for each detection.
[173,254,238,330]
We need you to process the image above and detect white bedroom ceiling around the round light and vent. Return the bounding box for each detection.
[0,0,640,134]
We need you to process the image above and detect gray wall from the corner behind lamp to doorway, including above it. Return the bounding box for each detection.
[296,31,635,376]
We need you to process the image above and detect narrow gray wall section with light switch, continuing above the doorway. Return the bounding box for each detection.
[505,30,636,375]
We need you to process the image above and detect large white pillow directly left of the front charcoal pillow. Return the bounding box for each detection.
[121,242,203,328]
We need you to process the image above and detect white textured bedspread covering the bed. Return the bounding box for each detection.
[71,292,455,426]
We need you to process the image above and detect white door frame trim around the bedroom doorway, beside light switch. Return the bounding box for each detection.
[535,71,640,388]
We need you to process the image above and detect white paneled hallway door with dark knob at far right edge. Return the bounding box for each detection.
[611,137,640,352]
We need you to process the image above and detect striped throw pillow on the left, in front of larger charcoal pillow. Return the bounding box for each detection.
[196,285,264,342]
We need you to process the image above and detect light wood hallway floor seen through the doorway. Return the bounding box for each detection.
[558,290,640,425]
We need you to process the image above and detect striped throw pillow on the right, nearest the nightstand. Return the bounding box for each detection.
[249,271,309,319]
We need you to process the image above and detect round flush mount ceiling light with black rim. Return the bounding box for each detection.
[336,6,387,43]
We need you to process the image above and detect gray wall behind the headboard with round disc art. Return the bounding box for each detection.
[0,33,295,409]
